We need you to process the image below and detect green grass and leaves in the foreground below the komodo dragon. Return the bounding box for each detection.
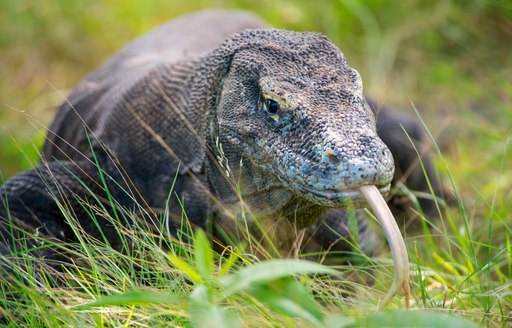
[0,187,496,327]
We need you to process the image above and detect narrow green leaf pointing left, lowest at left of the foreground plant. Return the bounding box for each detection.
[75,290,187,310]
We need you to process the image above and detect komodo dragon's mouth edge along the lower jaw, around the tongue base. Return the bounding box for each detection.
[303,184,391,208]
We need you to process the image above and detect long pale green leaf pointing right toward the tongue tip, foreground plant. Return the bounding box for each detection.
[220,260,336,297]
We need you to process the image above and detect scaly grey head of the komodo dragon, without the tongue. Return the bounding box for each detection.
[210,30,394,208]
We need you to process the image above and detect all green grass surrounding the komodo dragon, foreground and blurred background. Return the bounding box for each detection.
[0,0,512,327]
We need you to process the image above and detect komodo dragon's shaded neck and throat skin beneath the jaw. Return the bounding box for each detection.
[206,129,325,229]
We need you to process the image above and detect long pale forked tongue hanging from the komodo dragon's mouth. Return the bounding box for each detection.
[360,186,410,308]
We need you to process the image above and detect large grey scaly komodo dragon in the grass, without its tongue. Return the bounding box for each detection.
[0,11,440,264]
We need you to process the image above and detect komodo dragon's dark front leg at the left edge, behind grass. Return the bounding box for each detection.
[0,161,127,259]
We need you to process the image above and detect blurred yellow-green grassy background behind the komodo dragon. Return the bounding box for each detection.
[0,0,512,210]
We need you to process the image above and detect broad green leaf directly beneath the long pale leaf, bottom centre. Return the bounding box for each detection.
[247,277,324,326]
